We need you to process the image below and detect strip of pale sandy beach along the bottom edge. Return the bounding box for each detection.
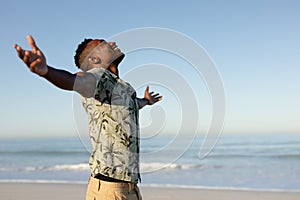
[0,183,300,200]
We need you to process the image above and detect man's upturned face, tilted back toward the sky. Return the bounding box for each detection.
[88,40,124,68]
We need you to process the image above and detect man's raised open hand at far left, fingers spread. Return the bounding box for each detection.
[14,35,48,76]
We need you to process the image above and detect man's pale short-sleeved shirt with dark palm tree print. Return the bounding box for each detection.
[81,68,140,182]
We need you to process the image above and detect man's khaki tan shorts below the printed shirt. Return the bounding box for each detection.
[86,177,142,200]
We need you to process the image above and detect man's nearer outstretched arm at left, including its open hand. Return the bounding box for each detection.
[14,35,96,97]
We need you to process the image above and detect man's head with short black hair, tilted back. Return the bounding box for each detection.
[74,39,125,71]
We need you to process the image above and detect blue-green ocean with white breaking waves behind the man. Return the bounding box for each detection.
[0,134,300,191]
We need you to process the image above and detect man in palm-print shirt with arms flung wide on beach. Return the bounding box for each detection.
[14,35,162,200]
